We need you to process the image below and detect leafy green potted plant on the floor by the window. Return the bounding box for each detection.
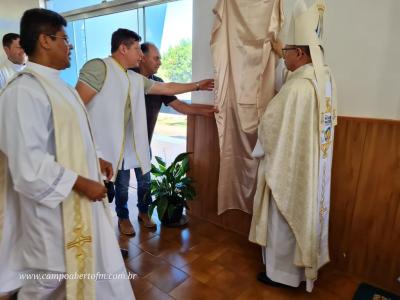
[149,152,196,226]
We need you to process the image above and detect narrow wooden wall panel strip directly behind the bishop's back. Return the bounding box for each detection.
[329,118,367,271]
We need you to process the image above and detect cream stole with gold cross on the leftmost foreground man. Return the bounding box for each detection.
[21,69,97,300]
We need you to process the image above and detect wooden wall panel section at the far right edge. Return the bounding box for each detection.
[348,122,400,291]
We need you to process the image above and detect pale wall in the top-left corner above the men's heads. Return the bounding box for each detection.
[0,0,41,60]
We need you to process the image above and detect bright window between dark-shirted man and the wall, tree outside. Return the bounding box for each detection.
[145,0,192,163]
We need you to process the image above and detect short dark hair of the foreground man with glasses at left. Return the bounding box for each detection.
[20,8,67,55]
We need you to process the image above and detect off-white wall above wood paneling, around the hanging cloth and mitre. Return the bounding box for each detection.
[193,0,400,120]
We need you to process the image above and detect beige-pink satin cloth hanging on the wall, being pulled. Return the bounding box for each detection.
[211,0,283,214]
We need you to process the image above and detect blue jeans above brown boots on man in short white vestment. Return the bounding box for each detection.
[115,168,152,219]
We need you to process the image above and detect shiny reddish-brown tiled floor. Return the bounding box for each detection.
[116,189,359,300]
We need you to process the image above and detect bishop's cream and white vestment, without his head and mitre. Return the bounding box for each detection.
[249,64,336,291]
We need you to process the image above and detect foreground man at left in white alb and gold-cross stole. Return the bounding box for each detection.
[0,9,134,300]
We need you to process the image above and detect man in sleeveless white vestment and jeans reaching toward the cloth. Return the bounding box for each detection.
[76,28,214,235]
